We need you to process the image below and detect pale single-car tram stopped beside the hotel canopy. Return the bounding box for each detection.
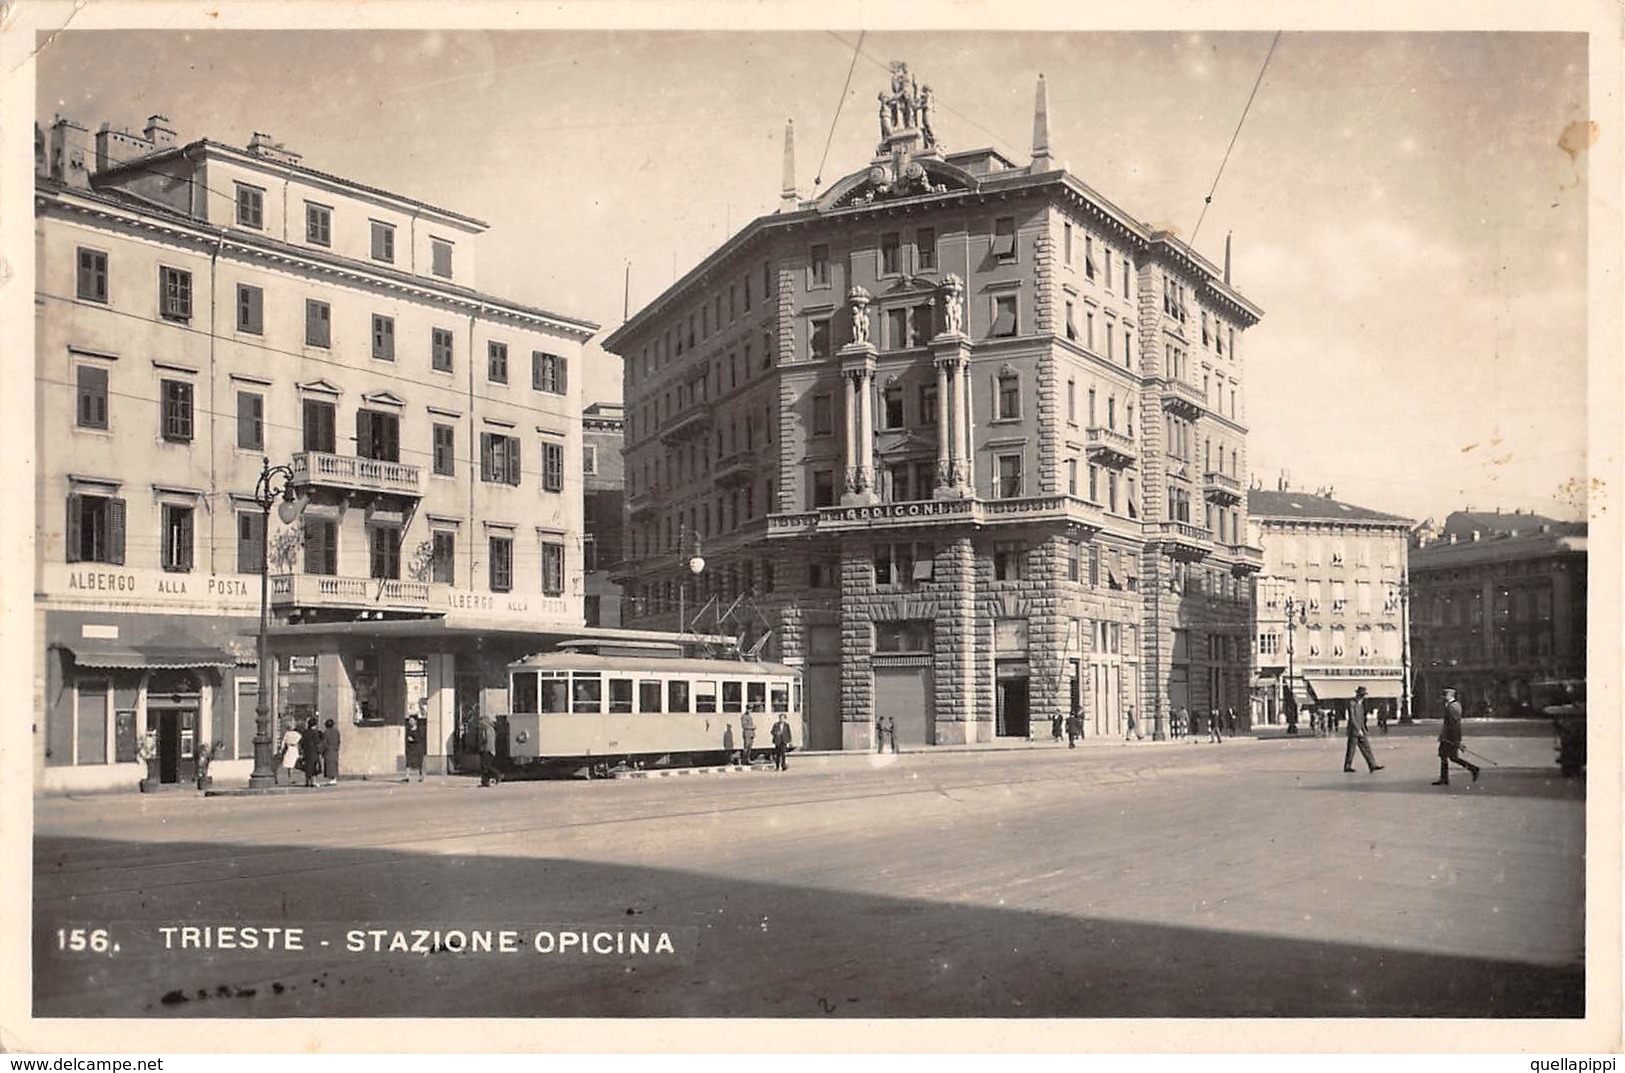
[505,650,806,772]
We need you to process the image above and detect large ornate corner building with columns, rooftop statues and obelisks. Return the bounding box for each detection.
[605,65,1263,749]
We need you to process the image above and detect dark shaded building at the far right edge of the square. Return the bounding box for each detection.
[1411,510,1588,715]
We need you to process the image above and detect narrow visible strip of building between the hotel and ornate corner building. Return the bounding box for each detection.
[582,402,626,626]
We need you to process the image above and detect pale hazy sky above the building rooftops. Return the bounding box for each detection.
[36,29,1588,520]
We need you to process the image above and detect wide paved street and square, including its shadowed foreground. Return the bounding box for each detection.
[34,727,1584,1018]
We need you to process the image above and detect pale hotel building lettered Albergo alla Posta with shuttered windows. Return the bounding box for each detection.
[34,115,596,788]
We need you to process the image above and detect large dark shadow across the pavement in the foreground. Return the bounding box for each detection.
[33,832,1584,1018]
